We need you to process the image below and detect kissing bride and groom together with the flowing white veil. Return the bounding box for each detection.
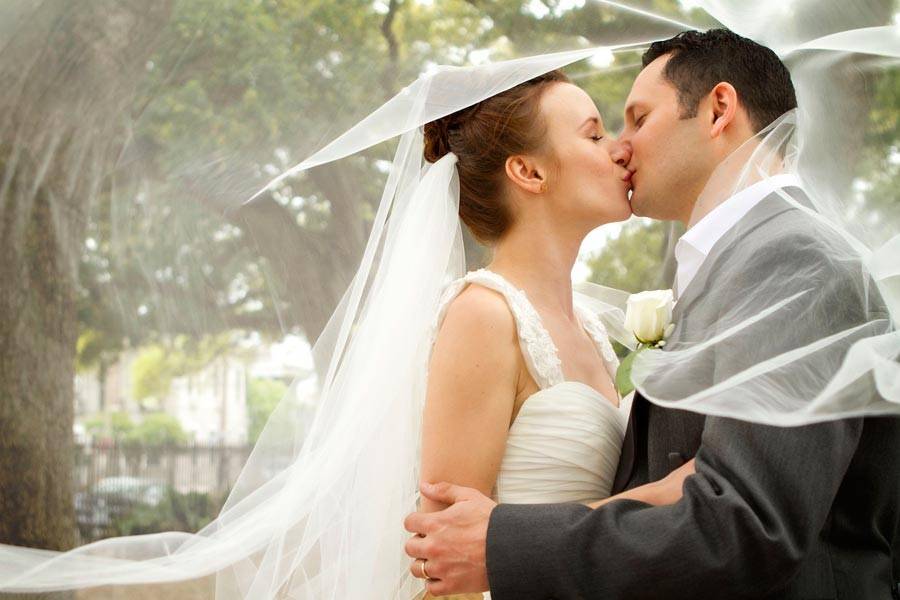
[0,21,900,600]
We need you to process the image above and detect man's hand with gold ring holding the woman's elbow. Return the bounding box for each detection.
[403,483,497,596]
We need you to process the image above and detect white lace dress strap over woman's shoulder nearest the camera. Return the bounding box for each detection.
[435,269,564,389]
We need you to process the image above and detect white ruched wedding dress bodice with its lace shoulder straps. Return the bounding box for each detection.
[437,269,630,504]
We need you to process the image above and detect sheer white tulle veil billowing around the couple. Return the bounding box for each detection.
[0,0,900,600]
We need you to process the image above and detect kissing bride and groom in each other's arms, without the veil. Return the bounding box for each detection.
[405,30,900,600]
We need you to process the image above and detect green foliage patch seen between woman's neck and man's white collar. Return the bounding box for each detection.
[587,222,669,293]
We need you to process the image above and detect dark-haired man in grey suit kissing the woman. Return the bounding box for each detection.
[406,30,900,600]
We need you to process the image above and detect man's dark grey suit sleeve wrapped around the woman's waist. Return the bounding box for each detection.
[487,418,862,600]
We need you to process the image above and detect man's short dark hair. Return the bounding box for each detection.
[642,29,797,132]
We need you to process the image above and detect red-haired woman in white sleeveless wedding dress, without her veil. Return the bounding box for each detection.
[413,71,692,596]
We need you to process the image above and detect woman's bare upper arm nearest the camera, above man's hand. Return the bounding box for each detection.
[419,286,521,512]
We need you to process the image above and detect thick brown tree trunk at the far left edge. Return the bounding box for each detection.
[0,0,170,598]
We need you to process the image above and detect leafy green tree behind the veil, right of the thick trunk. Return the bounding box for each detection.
[72,0,704,360]
